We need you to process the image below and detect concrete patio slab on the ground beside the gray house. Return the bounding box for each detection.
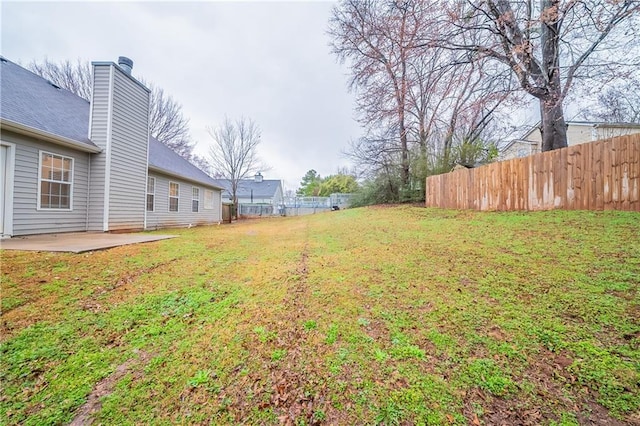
[0,232,177,253]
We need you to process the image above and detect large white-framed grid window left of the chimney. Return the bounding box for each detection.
[38,151,73,210]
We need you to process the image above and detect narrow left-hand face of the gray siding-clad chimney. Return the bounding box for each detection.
[88,66,110,231]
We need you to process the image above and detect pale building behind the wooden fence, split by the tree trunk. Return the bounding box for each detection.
[499,121,640,160]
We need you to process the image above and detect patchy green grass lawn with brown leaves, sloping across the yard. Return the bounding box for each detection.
[0,206,640,425]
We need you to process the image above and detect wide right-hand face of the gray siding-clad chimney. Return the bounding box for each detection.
[109,69,149,231]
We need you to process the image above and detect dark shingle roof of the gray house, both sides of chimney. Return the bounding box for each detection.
[0,56,220,188]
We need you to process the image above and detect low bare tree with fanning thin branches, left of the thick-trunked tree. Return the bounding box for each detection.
[408,47,518,168]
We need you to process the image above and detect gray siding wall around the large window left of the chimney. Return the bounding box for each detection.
[0,131,90,236]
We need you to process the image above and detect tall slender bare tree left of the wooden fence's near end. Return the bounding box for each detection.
[329,0,427,187]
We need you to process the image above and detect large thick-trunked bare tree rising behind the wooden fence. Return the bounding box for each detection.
[442,0,640,151]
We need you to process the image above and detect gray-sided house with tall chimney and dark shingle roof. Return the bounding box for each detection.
[0,57,222,237]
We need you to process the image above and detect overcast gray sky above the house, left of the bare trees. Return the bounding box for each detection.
[0,1,360,189]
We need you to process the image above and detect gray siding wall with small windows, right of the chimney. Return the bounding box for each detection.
[147,171,222,229]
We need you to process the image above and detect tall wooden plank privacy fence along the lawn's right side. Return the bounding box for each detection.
[426,133,640,211]
